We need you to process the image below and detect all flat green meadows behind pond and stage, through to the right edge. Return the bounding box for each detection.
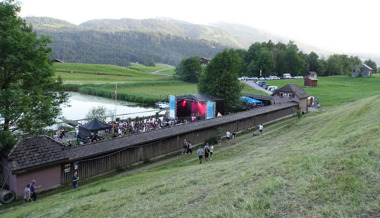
[55,63,380,107]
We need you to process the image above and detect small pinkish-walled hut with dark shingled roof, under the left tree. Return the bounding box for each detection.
[1,136,69,196]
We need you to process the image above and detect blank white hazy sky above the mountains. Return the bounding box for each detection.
[19,0,380,55]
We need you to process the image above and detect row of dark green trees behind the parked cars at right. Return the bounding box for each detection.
[236,40,377,77]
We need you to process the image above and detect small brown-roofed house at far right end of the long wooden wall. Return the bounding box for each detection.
[272,84,309,113]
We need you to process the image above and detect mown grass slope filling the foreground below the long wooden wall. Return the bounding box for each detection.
[0,95,380,217]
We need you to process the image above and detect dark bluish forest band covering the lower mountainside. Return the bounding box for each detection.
[40,30,223,66]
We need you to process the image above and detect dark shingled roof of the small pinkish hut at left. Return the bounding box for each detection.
[5,136,68,171]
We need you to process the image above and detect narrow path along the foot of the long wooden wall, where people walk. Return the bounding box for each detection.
[115,118,295,177]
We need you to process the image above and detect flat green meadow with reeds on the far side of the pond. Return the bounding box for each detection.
[55,63,264,105]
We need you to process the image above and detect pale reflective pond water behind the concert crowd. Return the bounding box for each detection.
[61,92,159,120]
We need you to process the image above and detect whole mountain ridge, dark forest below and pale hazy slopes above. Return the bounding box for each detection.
[26,17,280,66]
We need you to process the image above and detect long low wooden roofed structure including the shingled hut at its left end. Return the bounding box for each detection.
[1,102,298,197]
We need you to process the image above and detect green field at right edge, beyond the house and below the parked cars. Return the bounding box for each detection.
[268,74,380,106]
